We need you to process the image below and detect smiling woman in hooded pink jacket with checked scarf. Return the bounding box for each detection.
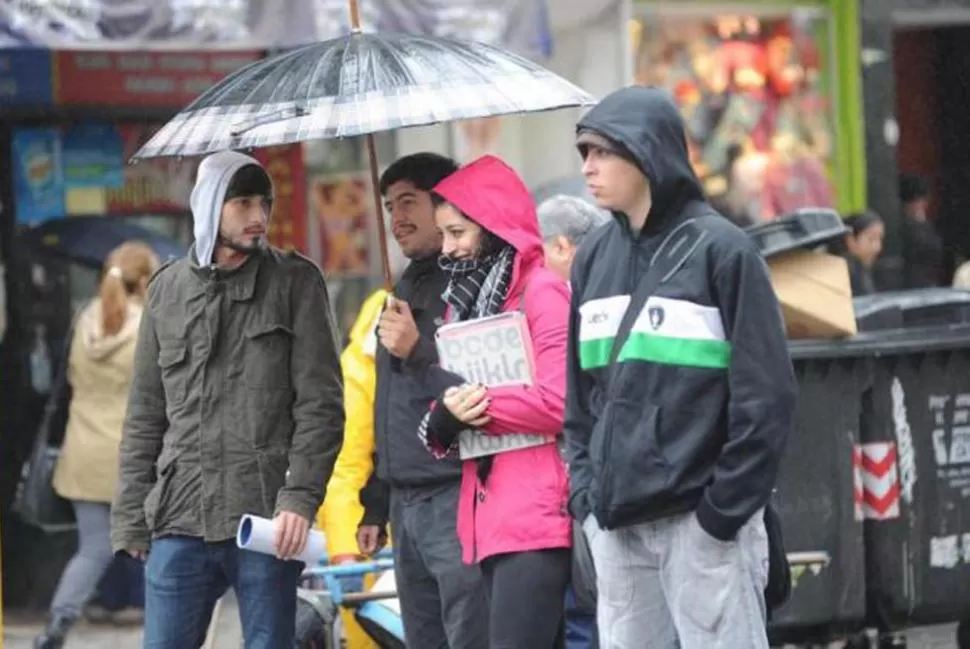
[419,156,572,649]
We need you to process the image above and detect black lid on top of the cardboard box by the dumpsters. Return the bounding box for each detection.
[745,207,849,257]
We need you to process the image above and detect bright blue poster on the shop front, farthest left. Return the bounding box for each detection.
[11,128,65,225]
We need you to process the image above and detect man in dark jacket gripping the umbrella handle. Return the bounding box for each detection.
[358,153,488,649]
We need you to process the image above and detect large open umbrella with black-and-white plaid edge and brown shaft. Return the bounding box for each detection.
[132,0,595,290]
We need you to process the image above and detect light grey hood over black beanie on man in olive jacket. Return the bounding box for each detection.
[189,151,272,266]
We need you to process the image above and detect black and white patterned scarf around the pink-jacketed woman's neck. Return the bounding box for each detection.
[438,244,515,322]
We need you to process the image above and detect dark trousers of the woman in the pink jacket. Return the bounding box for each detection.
[481,549,572,649]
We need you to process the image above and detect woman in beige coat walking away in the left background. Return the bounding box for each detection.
[34,242,159,649]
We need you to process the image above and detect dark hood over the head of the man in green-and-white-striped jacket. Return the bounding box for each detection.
[576,86,704,229]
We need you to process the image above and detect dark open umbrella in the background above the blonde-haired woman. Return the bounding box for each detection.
[22,216,185,267]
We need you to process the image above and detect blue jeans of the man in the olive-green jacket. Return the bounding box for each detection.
[144,536,303,649]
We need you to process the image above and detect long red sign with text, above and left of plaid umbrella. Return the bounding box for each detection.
[54,50,263,108]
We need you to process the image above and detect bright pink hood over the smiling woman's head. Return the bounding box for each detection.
[434,155,542,284]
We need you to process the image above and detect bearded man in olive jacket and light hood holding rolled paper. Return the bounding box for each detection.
[111,152,344,649]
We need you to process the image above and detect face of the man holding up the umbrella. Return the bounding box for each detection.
[384,180,441,259]
